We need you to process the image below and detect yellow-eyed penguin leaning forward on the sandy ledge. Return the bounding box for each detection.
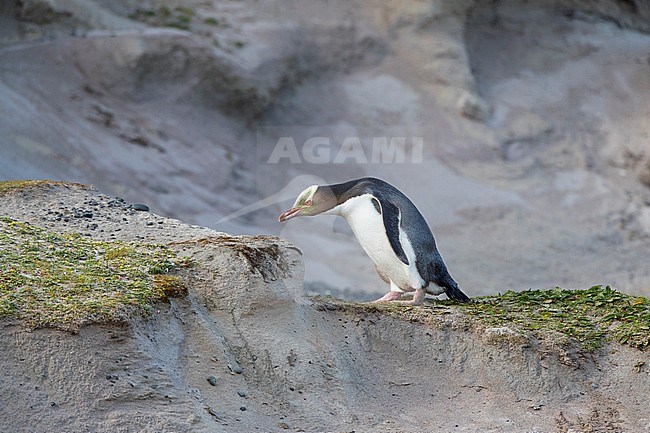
[278,177,470,305]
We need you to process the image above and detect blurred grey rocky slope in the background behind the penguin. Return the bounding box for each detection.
[0,0,650,299]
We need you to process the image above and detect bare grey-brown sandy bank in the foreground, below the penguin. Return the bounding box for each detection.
[0,184,650,433]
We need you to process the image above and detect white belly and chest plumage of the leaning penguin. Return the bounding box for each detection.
[331,194,424,291]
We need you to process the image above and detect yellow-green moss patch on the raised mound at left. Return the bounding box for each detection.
[0,217,187,330]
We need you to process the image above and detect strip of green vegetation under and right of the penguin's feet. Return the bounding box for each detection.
[316,286,650,352]
